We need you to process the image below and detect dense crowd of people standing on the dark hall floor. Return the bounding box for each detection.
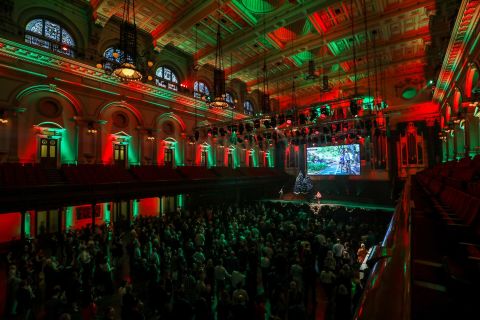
[5,202,391,320]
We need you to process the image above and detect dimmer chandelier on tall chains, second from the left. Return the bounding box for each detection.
[208,22,228,109]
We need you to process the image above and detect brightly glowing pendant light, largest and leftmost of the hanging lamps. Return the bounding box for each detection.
[113,0,142,82]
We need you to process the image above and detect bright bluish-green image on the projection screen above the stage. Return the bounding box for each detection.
[307,144,360,176]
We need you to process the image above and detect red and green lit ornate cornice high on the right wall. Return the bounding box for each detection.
[433,0,480,107]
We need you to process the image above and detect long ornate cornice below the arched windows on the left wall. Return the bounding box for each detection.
[0,38,246,119]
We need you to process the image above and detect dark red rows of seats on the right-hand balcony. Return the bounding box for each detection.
[416,156,480,308]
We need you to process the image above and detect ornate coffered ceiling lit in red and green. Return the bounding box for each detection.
[90,0,458,109]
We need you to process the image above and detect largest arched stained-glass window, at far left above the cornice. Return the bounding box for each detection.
[25,18,76,57]
